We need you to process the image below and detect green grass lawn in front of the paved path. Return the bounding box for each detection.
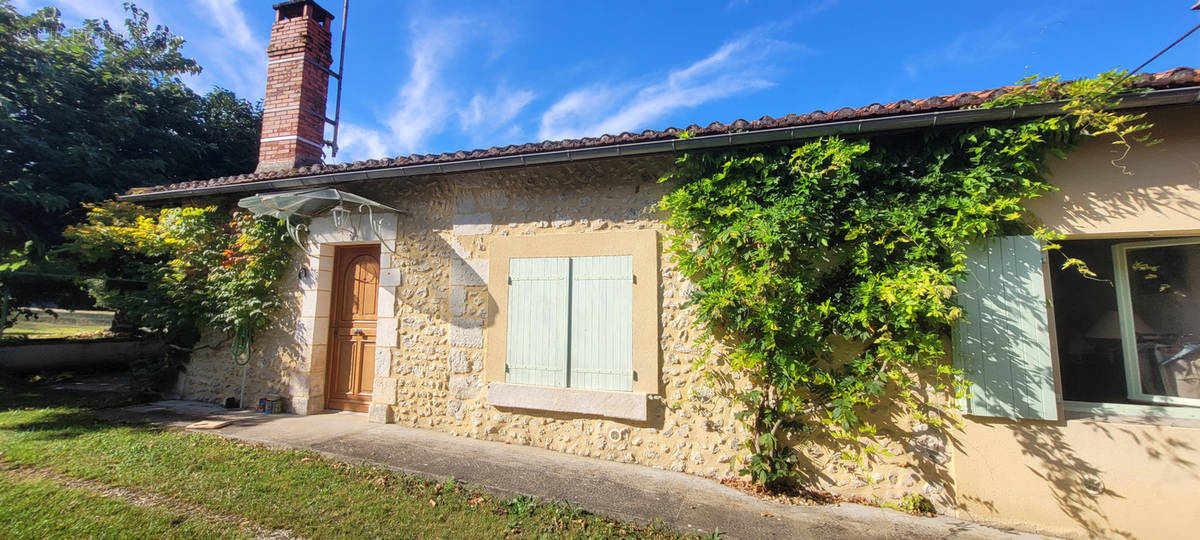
[0,378,676,538]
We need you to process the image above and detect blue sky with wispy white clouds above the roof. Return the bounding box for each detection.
[11,0,1200,162]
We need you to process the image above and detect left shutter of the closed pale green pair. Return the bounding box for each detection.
[505,258,570,386]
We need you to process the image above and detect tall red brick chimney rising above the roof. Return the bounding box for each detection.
[256,0,334,172]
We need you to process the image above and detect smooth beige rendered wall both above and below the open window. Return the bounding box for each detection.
[952,107,1200,539]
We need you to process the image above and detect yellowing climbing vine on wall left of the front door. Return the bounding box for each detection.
[62,202,294,386]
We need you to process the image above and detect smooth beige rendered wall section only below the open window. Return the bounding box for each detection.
[954,418,1200,539]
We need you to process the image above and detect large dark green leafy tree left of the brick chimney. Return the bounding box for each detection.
[0,0,262,331]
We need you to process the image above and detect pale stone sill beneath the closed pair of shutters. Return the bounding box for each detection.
[487,383,649,422]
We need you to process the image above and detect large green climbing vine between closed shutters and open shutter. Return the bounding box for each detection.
[660,72,1150,487]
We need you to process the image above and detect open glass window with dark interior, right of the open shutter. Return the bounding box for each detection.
[1051,234,1200,406]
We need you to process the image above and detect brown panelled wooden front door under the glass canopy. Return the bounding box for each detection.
[325,246,379,412]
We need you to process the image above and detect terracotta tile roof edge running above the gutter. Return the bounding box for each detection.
[131,67,1200,193]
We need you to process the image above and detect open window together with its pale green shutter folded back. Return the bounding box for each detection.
[954,236,1200,420]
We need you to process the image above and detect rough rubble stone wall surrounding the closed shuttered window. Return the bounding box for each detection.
[177,157,953,508]
